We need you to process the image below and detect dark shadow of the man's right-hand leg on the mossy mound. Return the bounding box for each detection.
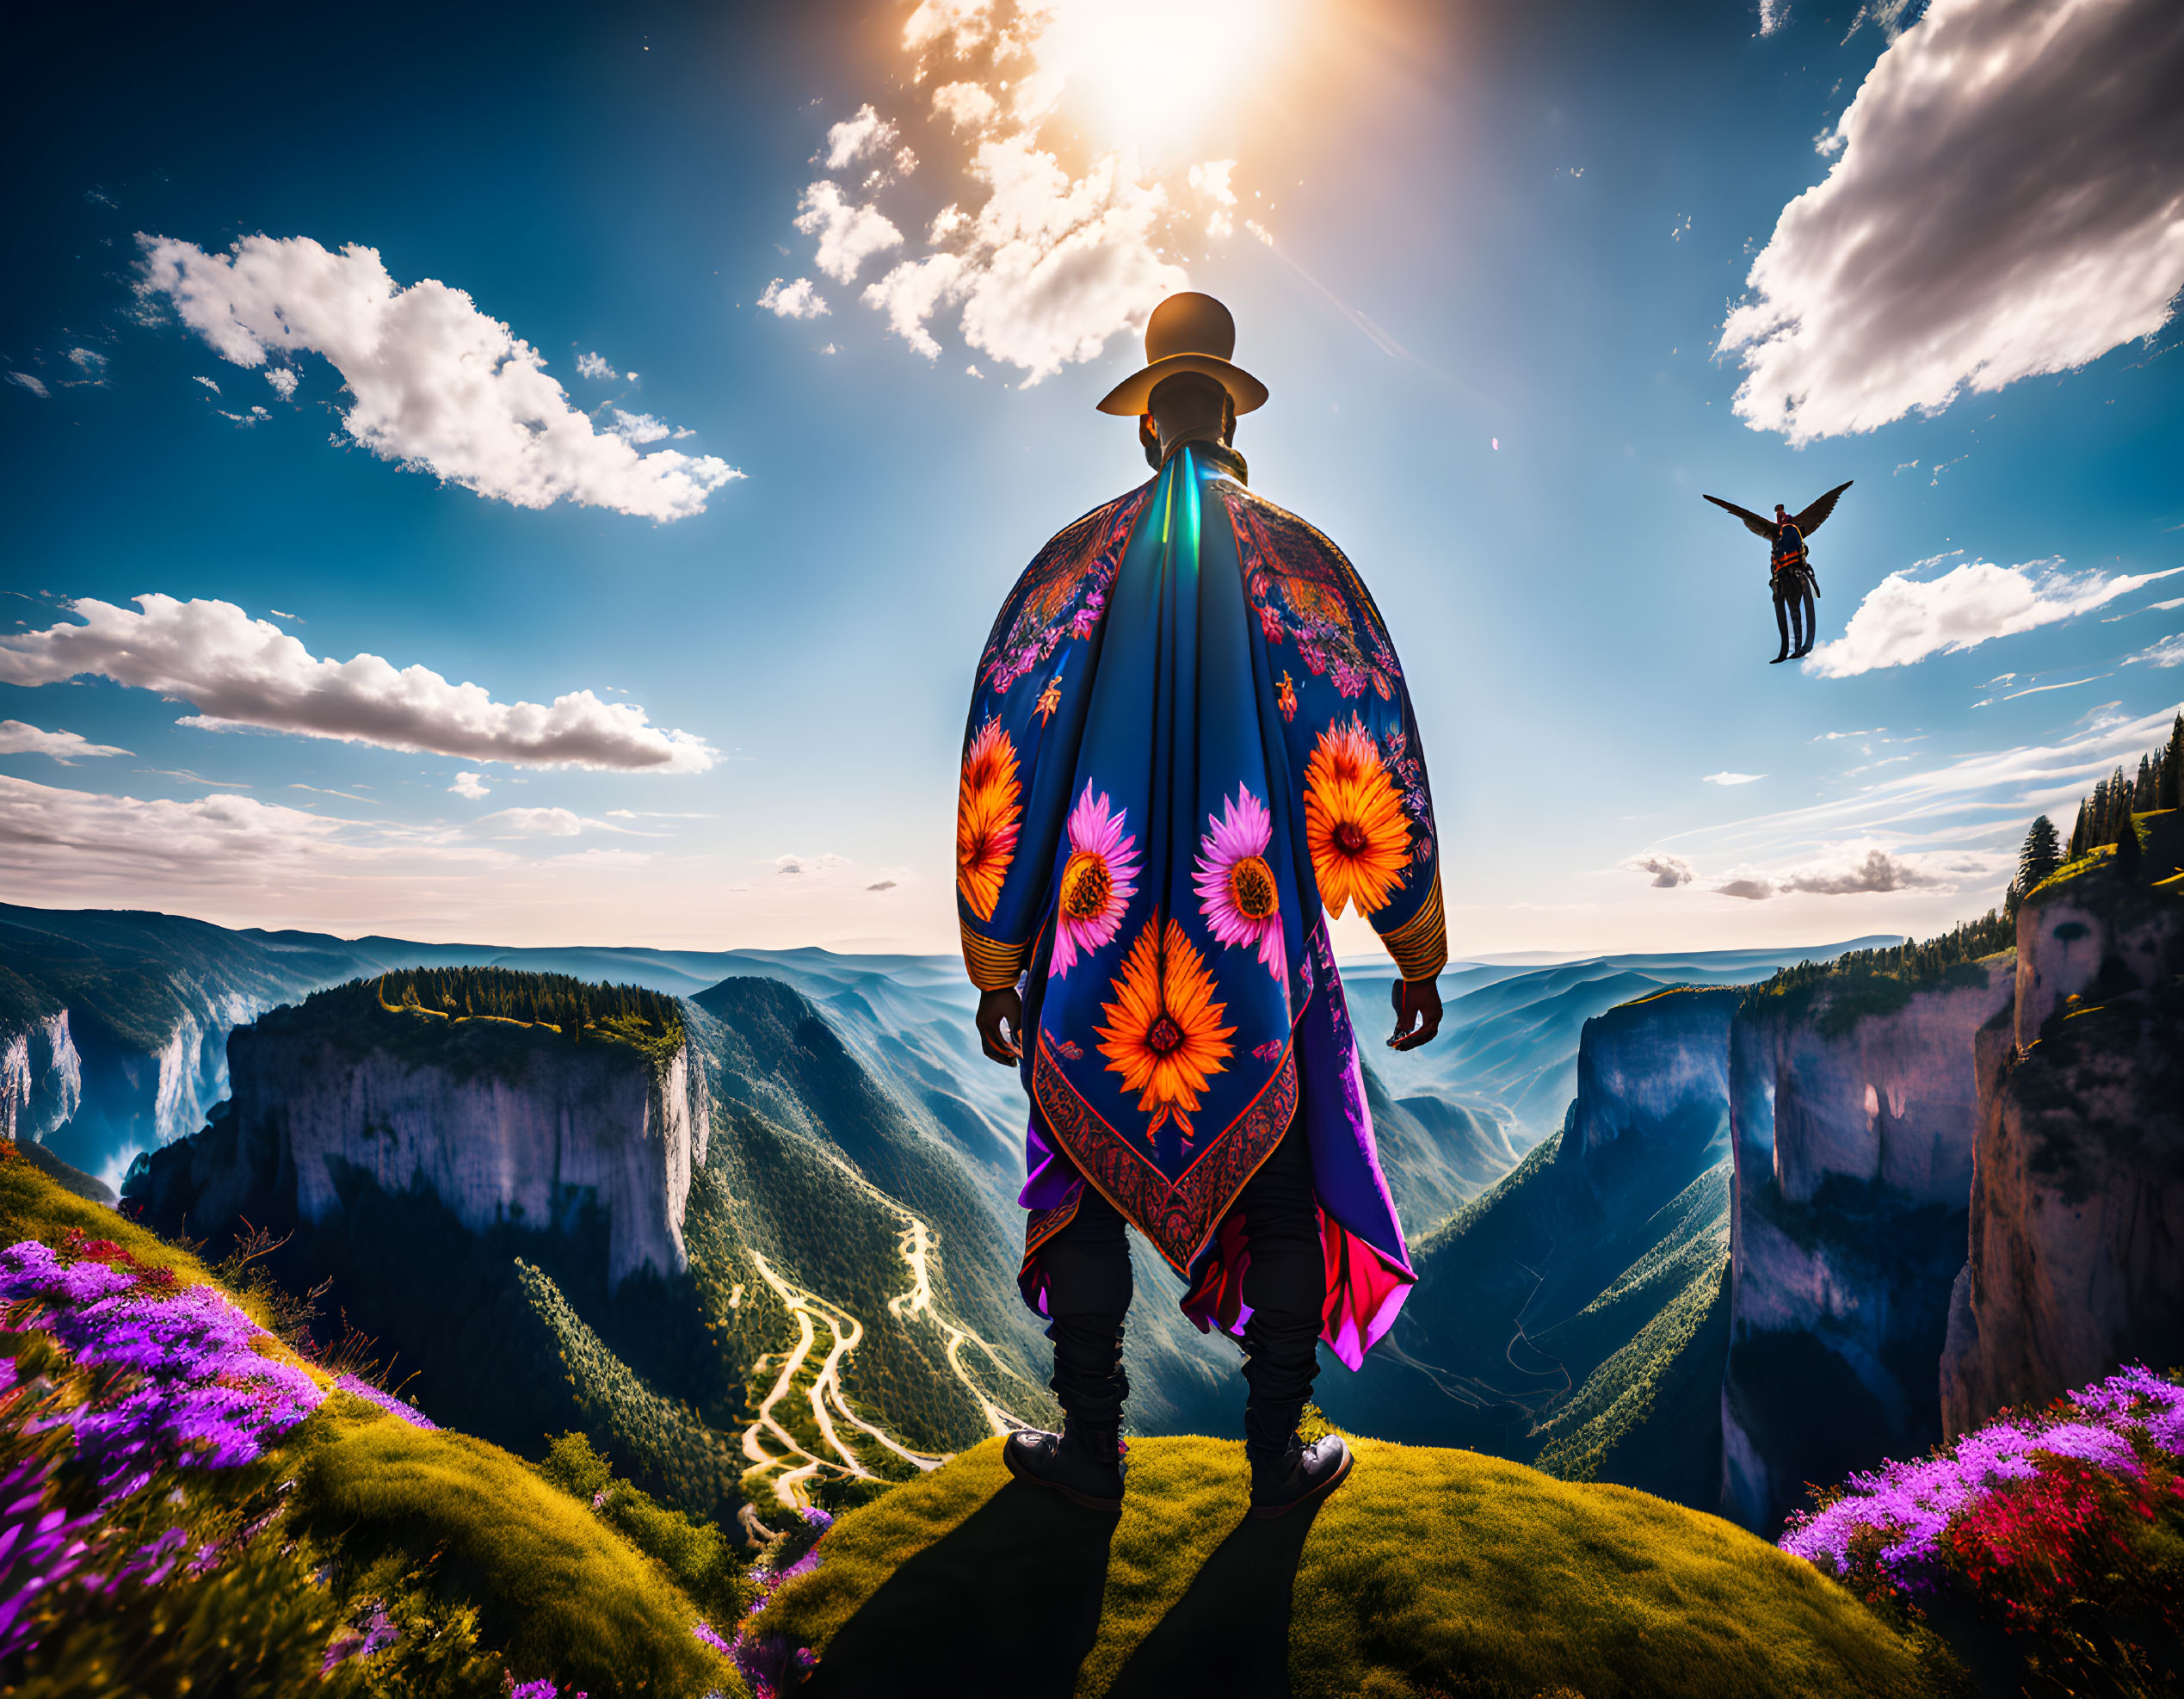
[1109,1503,1319,1699]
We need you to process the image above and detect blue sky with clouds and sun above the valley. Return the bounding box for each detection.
[0,0,2184,959]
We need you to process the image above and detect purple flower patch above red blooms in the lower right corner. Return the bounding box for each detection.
[1782,1362,2184,1592]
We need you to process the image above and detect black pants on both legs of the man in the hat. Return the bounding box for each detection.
[1040,1125,1326,1435]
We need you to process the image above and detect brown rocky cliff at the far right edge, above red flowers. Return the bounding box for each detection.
[1941,830,2184,1435]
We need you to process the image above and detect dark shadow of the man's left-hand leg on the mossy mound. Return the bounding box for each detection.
[797,1480,1116,1699]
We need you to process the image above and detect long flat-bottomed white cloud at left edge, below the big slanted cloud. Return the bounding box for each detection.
[0,596,716,773]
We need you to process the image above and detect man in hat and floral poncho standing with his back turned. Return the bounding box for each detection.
[957,293,1448,1516]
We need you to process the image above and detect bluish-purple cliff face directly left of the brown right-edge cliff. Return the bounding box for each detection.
[1721,955,2016,1533]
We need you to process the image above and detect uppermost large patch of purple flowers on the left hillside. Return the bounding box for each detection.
[0,1240,325,1500]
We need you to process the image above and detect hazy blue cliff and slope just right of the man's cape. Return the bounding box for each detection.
[1317,989,1737,1509]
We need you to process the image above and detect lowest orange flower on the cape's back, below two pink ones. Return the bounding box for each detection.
[1095,915,1237,1138]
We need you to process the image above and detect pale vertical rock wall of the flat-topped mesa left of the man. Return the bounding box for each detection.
[136,1009,712,1286]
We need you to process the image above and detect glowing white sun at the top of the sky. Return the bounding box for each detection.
[1035,0,1317,164]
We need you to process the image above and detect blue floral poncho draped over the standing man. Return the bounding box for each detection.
[957,443,1448,1367]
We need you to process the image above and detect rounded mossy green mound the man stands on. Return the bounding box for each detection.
[756,1439,1931,1699]
